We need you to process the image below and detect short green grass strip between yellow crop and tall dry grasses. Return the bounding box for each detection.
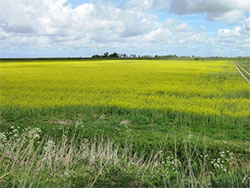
[0,106,250,157]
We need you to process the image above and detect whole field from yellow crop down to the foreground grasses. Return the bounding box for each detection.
[0,59,250,187]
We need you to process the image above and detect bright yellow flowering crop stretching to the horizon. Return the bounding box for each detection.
[0,60,250,117]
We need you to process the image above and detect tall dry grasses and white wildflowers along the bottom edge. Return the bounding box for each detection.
[0,122,249,187]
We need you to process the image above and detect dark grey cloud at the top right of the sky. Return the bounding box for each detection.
[152,0,250,24]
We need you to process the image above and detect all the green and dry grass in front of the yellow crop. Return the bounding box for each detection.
[0,107,250,187]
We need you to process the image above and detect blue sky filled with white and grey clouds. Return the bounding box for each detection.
[0,0,250,58]
